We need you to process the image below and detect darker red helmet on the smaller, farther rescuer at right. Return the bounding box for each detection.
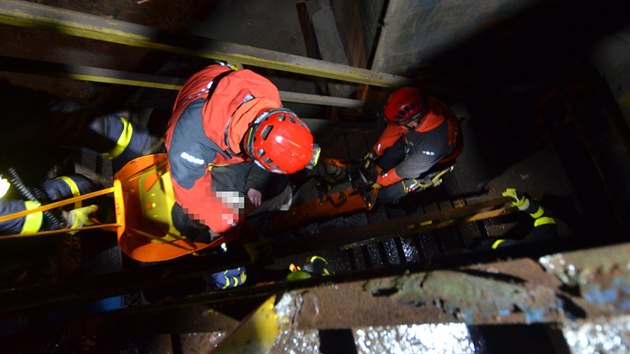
[384,87,426,124]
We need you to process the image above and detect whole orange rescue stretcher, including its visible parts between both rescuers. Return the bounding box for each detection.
[0,149,464,262]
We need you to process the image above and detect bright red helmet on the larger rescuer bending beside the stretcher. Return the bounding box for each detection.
[245,109,320,173]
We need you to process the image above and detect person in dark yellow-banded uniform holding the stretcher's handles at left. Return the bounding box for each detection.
[0,175,98,235]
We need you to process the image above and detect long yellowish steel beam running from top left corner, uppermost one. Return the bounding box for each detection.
[0,0,412,87]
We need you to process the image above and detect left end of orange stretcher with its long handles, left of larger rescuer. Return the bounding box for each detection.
[0,154,234,262]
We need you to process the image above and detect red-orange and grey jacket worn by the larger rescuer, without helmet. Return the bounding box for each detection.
[165,65,282,233]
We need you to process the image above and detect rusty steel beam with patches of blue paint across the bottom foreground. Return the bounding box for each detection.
[65,244,630,333]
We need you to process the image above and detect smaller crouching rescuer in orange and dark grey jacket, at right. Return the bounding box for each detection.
[364,87,462,204]
